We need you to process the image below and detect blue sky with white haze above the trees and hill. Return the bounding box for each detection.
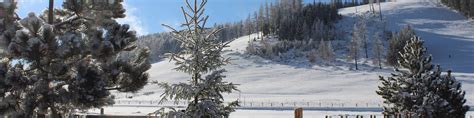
[18,0,320,35]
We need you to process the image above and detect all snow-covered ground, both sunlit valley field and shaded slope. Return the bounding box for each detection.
[104,0,474,118]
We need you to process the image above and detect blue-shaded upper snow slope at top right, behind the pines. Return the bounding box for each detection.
[340,0,474,73]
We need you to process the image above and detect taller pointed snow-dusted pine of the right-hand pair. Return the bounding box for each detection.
[376,37,433,115]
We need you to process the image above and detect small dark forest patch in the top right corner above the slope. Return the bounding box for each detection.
[441,0,474,18]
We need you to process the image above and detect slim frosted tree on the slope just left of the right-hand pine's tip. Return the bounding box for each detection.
[372,32,385,69]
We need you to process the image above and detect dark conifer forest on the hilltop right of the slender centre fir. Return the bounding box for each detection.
[215,0,386,40]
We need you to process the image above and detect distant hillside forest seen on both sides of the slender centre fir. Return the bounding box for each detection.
[137,0,385,62]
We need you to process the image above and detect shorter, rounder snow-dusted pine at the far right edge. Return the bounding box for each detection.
[414,65,469,118]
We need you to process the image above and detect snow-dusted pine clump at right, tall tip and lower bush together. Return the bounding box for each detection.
[376,37,469,118]
